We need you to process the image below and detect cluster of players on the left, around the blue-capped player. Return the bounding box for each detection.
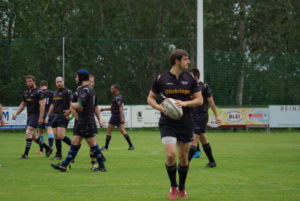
[12,69,134,172]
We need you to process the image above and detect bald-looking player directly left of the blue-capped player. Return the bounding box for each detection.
[46,77,72,160]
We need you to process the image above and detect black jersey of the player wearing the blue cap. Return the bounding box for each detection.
[77,85,96,123]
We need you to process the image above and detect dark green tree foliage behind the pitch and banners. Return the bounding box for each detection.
[0,0,300,106]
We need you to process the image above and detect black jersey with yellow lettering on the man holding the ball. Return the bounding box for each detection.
[151,71,200,119]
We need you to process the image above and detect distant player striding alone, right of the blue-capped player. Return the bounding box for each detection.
[100,84,134,150]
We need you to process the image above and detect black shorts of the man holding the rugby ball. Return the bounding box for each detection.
[159,119,193,143]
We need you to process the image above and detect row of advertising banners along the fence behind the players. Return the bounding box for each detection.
[0,105,272,129]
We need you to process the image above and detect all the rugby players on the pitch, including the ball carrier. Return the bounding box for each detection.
[1,49,220,200]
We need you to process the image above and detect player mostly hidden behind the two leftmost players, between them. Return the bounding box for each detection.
[37,80,54,154]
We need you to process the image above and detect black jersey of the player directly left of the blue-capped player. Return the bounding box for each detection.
[52,88,73,114]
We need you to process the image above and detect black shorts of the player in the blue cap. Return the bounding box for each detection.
[73,122,98,138]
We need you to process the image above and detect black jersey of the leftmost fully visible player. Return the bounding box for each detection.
[23,88,45,115]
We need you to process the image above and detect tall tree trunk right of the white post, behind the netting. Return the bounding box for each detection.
[236,0,246,106]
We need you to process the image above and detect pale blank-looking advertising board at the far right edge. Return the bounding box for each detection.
[269,105,300,128]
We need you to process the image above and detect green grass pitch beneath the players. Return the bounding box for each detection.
[0,131,300,201]
